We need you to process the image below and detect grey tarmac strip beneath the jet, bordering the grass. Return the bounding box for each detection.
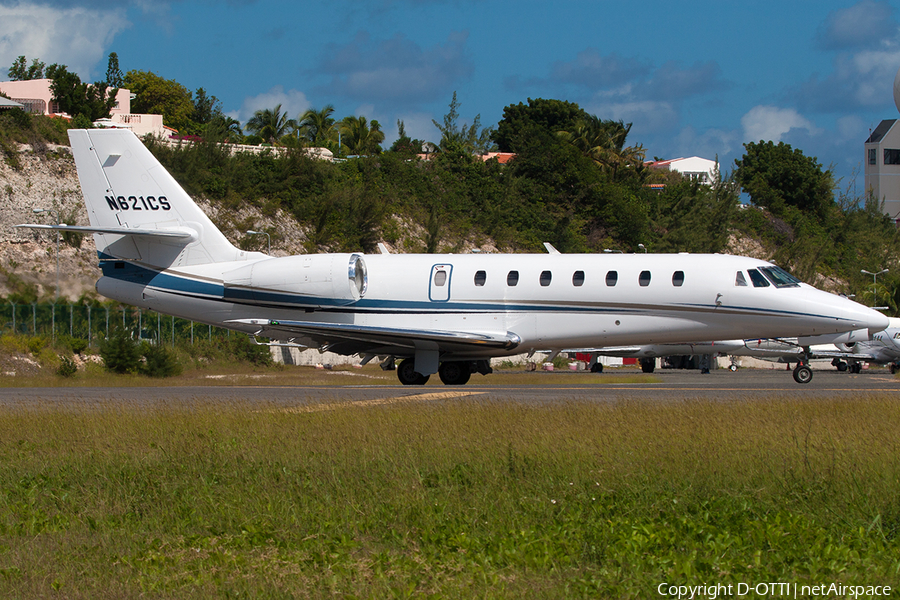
[0,369,900,408]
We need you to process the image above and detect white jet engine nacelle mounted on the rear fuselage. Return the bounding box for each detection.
[224,254,368,308]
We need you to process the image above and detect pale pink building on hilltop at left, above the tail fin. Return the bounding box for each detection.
[0,79,173,137]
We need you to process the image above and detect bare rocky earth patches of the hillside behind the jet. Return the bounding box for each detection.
[0,137,843,302]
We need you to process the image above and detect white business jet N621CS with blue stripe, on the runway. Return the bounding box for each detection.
[17,130,887,384]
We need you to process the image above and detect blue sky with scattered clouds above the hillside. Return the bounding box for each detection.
[0,0,900,192]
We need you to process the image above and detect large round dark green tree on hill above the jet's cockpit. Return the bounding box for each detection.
[734,141,835,218]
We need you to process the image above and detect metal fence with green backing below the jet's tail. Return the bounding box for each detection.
[0,302,231,346]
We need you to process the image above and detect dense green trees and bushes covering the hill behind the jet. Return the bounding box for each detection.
[0,53,900,313]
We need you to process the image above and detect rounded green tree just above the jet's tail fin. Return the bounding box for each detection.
[124,71,194,132]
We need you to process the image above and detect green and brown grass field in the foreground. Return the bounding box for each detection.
[0,396,900,598]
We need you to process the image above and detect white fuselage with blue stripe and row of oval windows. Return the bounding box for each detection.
[98,254,886,358]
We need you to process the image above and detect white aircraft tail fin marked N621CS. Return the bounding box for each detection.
[69,129,251,268]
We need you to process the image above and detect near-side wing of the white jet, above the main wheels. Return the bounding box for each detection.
[226,319,521,355]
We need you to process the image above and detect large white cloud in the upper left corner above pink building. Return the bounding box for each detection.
[0,3,131,81]
